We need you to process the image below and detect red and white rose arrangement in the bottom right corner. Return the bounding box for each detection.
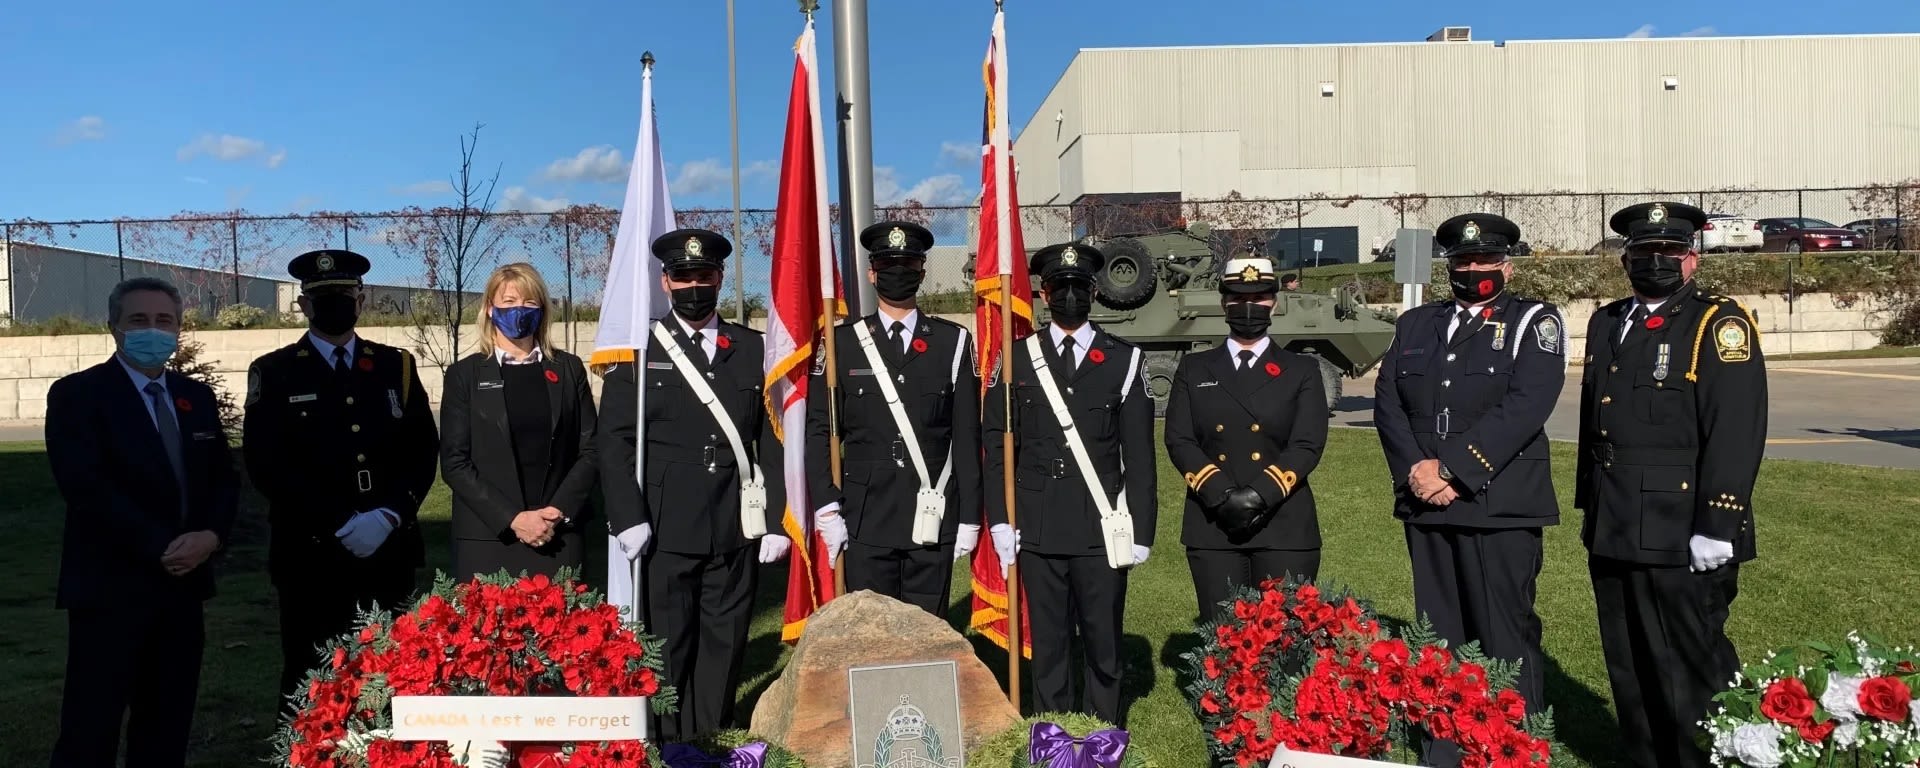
[1701,634,1920,768]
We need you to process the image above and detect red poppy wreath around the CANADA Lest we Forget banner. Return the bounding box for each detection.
[275,570,676,768]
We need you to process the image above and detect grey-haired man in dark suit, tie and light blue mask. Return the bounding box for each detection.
[46,276,240,768]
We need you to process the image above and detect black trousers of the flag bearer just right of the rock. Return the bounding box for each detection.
[1018,551,1127,726]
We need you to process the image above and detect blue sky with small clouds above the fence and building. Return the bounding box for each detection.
[0,0,1920,221]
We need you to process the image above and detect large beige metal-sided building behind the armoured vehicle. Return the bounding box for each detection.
[1014,27,1920,261]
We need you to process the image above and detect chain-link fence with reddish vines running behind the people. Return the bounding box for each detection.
[0,182,1920,332]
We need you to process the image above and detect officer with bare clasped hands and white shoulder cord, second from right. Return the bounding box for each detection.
[1373,213,1567,733]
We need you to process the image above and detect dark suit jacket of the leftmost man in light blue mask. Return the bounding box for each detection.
[46,357,240,609]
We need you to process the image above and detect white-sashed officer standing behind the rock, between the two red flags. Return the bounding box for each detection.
[806,221,979,618]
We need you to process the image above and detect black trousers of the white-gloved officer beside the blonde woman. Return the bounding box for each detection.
[275,549,413,710]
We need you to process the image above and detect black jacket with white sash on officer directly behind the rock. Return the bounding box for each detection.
[806,313,979,549]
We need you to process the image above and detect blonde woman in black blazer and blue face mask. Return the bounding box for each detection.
[440,263,599,578]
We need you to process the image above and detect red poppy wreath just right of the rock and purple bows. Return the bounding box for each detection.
[1185,580,1553,768]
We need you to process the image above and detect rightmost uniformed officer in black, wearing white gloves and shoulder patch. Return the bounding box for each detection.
[1574,202,1766,768]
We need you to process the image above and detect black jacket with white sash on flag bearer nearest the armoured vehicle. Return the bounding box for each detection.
[981,326,1160,555]
